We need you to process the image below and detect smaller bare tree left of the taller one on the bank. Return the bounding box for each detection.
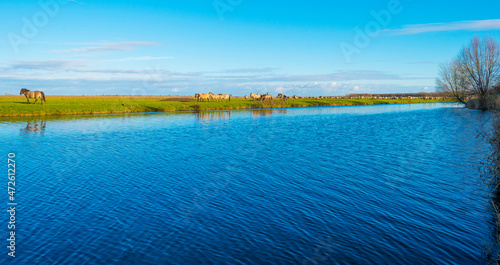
[436,59,473,104]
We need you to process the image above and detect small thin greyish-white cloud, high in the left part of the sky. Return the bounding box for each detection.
[51,41,161,55]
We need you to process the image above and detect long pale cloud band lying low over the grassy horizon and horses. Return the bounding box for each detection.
[0,57,433,95]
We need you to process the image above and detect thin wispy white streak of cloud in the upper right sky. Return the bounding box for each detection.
[383,19,500,35]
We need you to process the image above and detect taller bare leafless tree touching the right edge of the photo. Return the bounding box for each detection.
[458,36,500,109]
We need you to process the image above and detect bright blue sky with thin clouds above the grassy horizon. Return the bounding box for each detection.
[0,0,500,96]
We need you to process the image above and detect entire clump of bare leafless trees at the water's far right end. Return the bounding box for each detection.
[436,36,500,110]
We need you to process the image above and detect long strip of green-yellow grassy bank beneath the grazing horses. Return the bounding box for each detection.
[0,96,454,116]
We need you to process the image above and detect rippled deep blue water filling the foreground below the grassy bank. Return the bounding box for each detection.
[0,104,491,264]
